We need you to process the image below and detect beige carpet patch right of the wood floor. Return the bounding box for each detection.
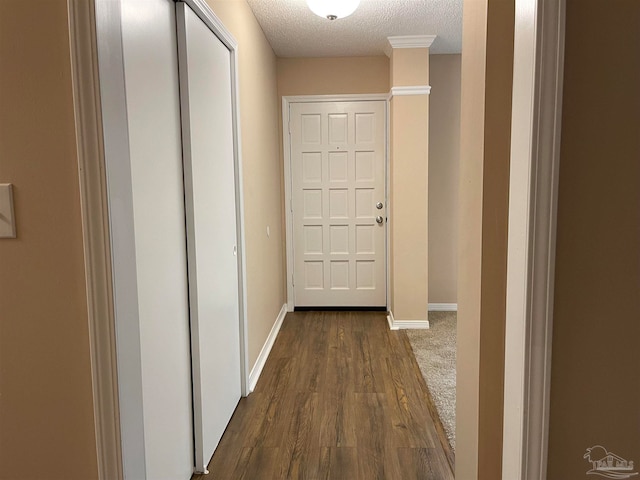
[407,312,457,452]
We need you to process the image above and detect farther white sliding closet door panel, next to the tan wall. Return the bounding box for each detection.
[177,3,241,472]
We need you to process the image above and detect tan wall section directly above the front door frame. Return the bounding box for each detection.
[278,56,389,97]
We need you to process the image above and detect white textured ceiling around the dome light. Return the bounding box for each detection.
[247,0,462,57]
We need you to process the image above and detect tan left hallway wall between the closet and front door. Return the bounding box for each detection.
[207,0,286,368]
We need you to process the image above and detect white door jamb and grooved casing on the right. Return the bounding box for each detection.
[502,0,565,480]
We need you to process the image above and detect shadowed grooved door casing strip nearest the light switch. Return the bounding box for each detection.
[68,0,124,480]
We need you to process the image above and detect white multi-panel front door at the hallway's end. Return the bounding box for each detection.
[289,101,387,307]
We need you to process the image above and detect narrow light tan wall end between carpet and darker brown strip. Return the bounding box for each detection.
[455,0,487,474]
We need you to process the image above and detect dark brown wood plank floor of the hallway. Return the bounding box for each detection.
[193,312,453,480]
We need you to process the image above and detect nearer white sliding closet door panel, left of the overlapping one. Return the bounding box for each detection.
[119,0,193,480]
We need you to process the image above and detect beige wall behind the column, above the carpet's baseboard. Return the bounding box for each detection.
[429,55,461,303]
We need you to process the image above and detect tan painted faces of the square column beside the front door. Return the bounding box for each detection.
[389,48,429,321]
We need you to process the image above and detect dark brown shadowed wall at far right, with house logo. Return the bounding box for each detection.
[547,0,640,480]
